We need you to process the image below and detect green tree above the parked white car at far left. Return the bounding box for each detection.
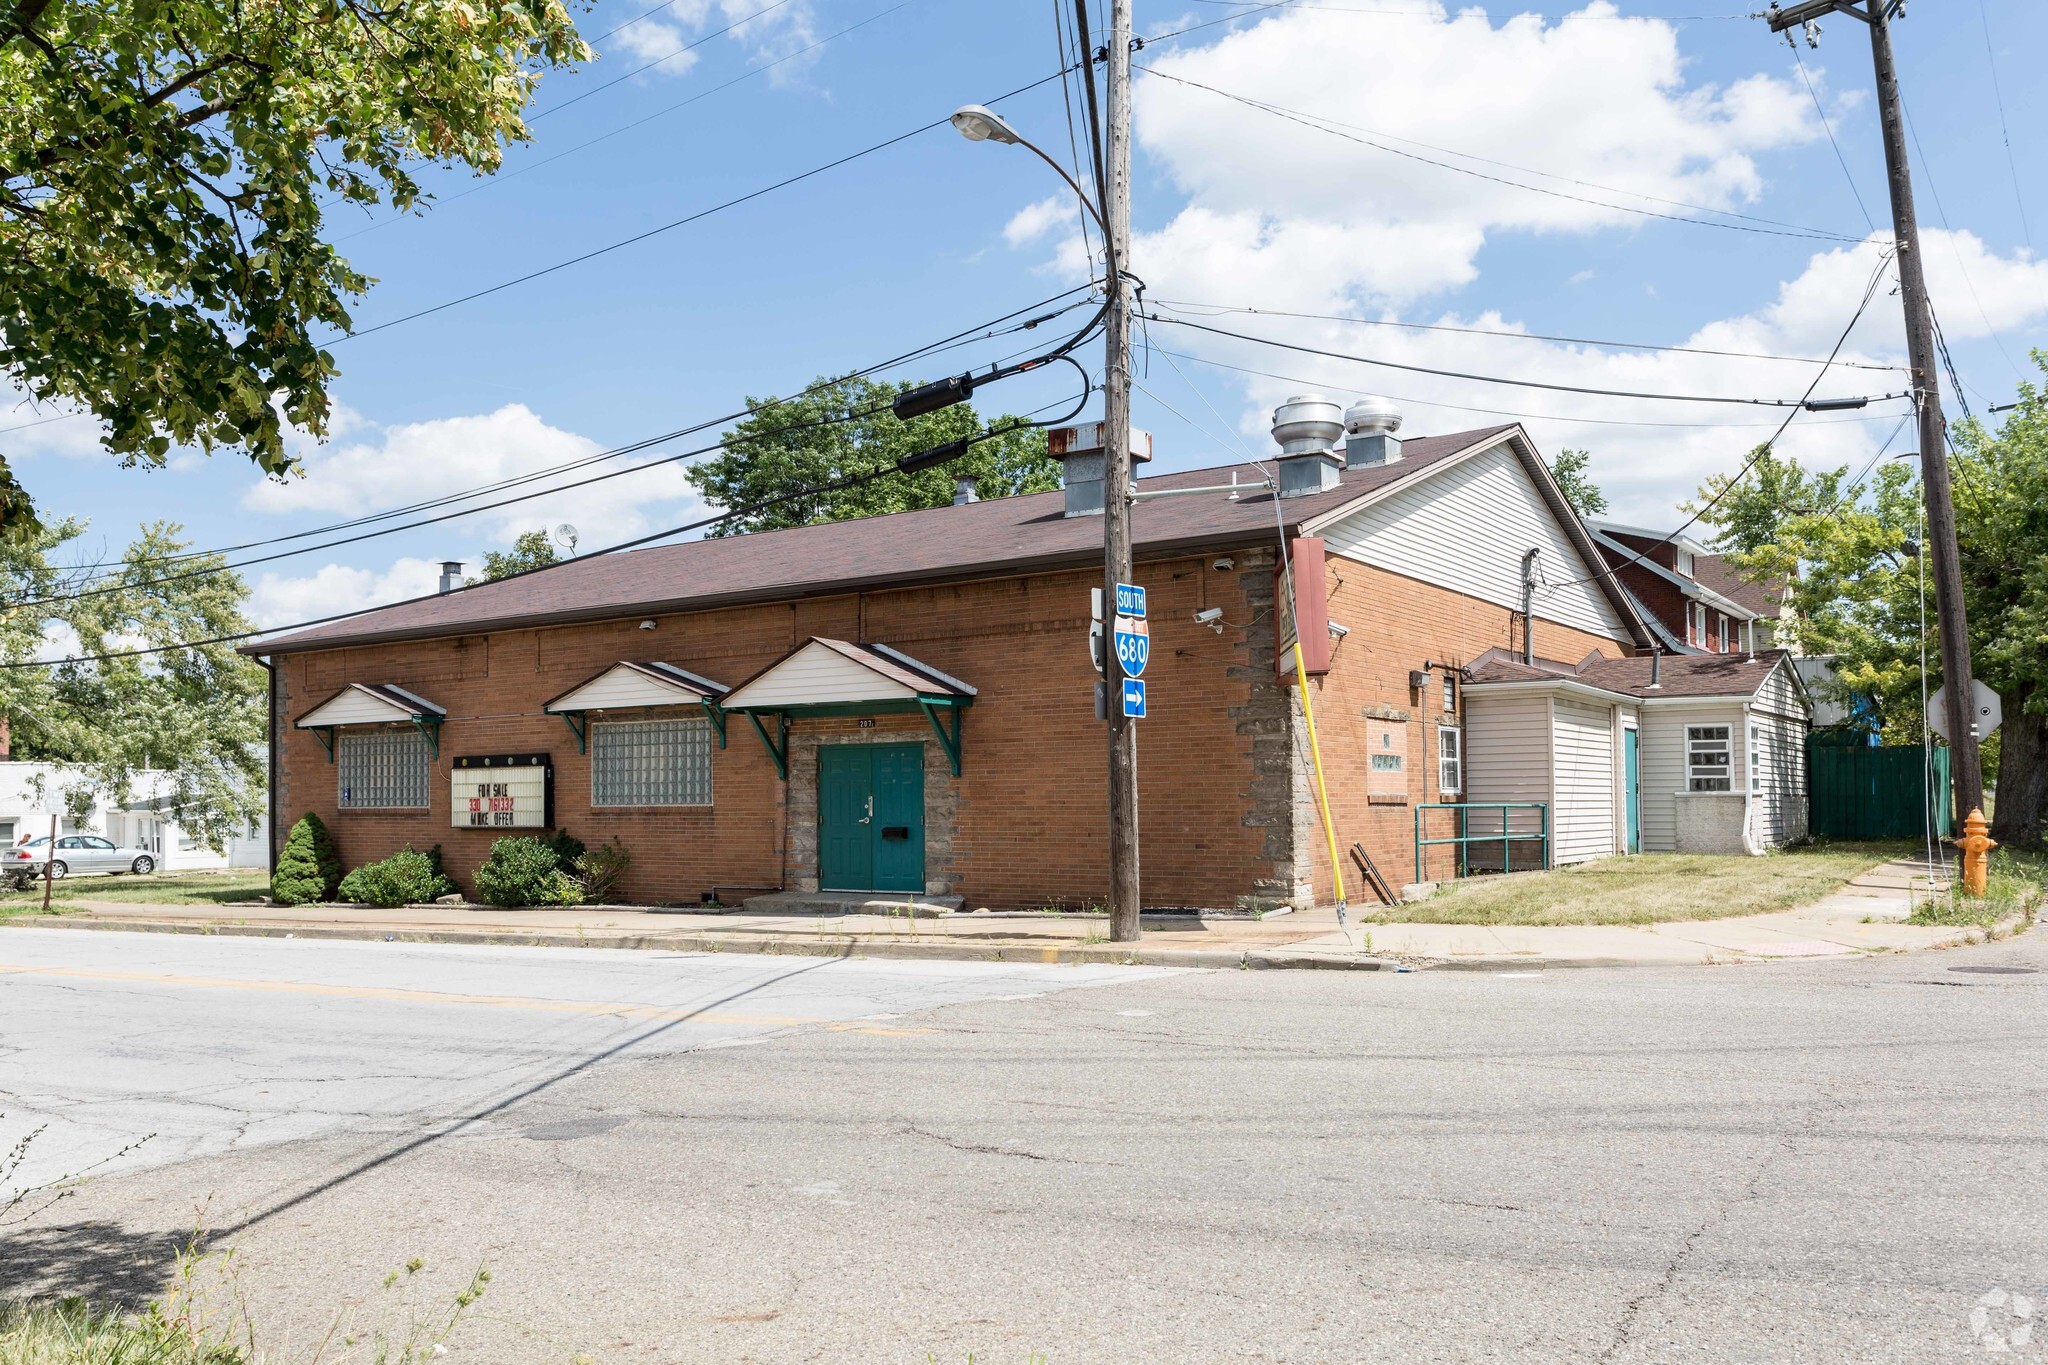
[0,522,266,847]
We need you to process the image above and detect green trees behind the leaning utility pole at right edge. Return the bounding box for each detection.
[1690,352,2048,847]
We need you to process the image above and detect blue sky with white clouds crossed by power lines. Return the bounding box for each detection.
[6,0,2048,624]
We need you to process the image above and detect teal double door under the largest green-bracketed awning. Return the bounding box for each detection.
[817,745,924,894]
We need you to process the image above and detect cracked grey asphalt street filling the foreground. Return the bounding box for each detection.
[0,931,2048,1365]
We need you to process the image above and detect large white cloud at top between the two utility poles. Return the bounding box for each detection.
[1133,0,1821,303]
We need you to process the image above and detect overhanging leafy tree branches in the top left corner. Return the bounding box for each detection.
[0,0,590,530]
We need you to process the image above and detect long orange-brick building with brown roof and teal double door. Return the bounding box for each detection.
[250,399,1794,907]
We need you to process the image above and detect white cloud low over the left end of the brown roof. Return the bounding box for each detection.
[242,403,702,551]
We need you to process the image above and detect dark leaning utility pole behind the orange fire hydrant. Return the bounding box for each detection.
[1763,0,1985,817]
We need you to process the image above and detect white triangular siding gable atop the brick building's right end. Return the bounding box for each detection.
[1321,444,1628,641]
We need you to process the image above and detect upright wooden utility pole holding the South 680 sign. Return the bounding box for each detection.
[1081,0,1143,943]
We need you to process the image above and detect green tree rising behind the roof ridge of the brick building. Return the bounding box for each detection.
[690,379,1059,536]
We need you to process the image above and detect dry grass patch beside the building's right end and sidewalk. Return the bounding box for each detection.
[1366,843,1913,925]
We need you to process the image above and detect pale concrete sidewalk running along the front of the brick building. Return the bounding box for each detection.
[0,860,2017,970]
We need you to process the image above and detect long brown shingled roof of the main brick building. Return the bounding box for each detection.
[244,424,1516,655]
